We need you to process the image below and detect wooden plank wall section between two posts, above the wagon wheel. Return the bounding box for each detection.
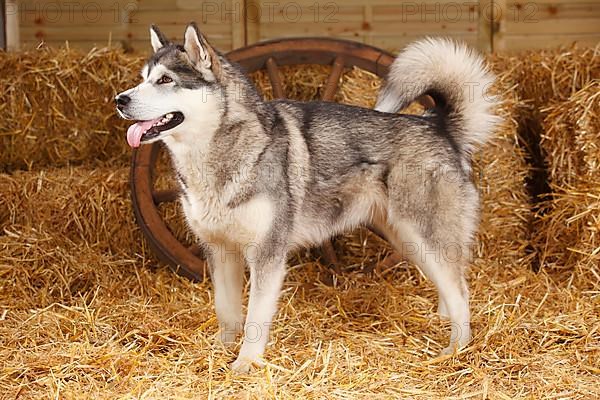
[248,0,479,51]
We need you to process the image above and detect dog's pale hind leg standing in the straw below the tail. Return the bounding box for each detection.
[379,220,471,354]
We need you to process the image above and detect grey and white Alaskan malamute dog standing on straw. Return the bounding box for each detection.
[115,23,497,372]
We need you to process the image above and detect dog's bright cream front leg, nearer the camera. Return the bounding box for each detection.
[231,256,285,373]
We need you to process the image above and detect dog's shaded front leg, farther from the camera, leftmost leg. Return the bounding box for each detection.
[208,244,245,346]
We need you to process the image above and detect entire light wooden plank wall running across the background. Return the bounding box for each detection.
[9,0,600,52]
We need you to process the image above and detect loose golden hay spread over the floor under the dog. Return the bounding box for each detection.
[0,168,600,399]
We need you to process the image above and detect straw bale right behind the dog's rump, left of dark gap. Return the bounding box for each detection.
[473,82,532,264]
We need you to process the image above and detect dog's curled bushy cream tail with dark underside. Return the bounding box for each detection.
[375,38,499,154]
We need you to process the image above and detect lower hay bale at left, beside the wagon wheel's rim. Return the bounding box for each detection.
[0,168,140,255]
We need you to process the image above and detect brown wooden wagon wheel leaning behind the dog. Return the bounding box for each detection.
[131,38,404,280]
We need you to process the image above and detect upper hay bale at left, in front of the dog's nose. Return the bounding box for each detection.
[0,48,142,171]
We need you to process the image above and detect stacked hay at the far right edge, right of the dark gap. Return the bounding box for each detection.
[492,45,600,272]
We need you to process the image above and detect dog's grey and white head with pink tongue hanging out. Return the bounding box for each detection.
[115,23,224,147]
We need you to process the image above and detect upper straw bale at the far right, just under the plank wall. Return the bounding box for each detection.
[490,44,600,182]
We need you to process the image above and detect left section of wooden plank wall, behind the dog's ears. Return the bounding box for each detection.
[18,0,245,51]
